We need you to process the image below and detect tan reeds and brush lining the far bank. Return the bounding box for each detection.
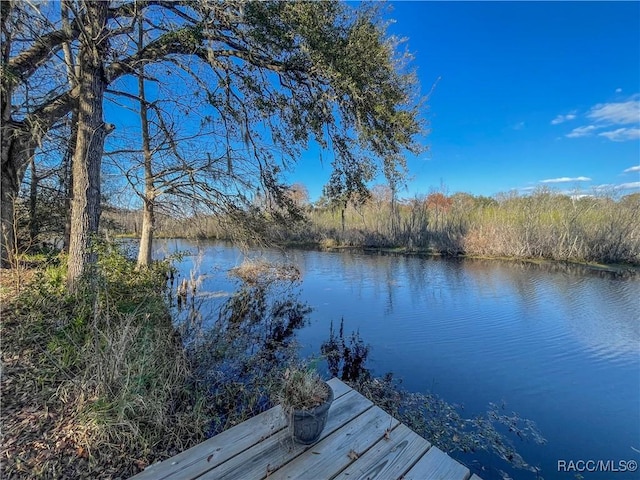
[108,188,640,265]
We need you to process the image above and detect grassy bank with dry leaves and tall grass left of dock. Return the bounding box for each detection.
[0,248,209,478]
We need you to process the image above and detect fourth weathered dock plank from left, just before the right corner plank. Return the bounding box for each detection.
[334,424,431,480]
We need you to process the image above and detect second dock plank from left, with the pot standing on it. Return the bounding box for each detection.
[198,390,373,480]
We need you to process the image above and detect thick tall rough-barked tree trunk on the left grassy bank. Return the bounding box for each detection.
[67,0,113,291]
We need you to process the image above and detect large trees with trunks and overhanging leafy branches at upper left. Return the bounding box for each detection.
[6,0,425,290]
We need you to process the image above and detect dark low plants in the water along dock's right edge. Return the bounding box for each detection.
[320,320,546,479]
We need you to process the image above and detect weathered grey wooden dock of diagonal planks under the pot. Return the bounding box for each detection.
[132,378,480,480]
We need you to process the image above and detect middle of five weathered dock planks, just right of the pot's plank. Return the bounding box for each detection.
[269,407,399,480]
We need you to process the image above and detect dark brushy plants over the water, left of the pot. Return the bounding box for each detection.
[180,262,311,435]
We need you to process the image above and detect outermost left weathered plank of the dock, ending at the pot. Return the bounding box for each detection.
[132,406,287,480]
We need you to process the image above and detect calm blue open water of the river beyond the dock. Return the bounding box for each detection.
[155,240,640,480]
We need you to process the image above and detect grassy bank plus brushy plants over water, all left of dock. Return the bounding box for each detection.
[0,249,309,478]
